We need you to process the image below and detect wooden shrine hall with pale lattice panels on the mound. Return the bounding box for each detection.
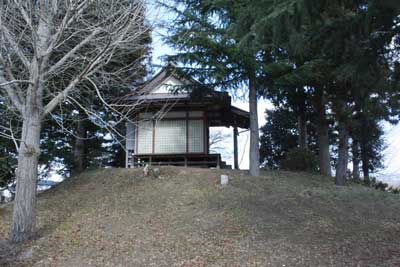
[126,65,250,169]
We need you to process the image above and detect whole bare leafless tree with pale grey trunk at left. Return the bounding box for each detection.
[0,0,148,242]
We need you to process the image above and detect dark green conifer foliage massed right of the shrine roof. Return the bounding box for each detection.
[167,0,400,185]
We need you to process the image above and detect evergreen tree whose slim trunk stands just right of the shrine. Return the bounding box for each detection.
[167,0,268,176]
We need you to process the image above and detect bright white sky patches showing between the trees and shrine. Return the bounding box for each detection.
[149,6,400,186]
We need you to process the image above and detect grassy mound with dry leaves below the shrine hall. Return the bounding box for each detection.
[0,167,400,266]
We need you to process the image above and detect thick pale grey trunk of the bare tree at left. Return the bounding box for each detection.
[10,111,41,242]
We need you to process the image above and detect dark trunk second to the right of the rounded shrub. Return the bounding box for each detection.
[336,118,349,186]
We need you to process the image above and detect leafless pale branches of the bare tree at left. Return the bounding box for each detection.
[0,0,155,147]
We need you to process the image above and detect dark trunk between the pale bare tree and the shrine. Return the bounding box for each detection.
[72,117,86,175]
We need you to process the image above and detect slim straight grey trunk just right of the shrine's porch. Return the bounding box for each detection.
[249,73,260,176]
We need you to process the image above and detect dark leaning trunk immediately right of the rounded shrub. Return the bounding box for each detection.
[317,94,332,177]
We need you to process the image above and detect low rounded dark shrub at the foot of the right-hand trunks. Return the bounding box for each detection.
[281,148,318,172]
